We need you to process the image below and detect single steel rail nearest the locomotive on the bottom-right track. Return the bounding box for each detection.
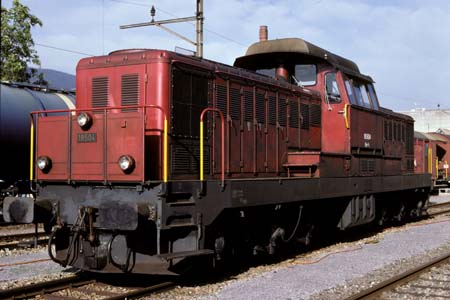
[344,253,450,300]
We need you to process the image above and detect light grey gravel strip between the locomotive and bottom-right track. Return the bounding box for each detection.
[194,220,450,300]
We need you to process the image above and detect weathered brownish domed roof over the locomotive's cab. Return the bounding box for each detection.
[234,38,373,82]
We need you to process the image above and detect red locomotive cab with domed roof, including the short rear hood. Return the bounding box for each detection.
[234,38,414,177]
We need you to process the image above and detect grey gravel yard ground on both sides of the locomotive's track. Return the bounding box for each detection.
[0,193,450,300]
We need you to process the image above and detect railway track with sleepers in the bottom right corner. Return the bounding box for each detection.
[345,253,450,300]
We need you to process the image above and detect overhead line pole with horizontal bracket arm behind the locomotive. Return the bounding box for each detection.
[120,0,204,57]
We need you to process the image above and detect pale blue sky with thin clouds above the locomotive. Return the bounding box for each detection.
[1,0,450,111]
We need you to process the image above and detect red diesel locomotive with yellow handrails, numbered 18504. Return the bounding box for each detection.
[4,29,431,274]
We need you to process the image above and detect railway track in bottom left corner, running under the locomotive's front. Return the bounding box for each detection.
[0,276,175,300]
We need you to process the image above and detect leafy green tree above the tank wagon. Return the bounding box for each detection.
[0,0,42,82]
